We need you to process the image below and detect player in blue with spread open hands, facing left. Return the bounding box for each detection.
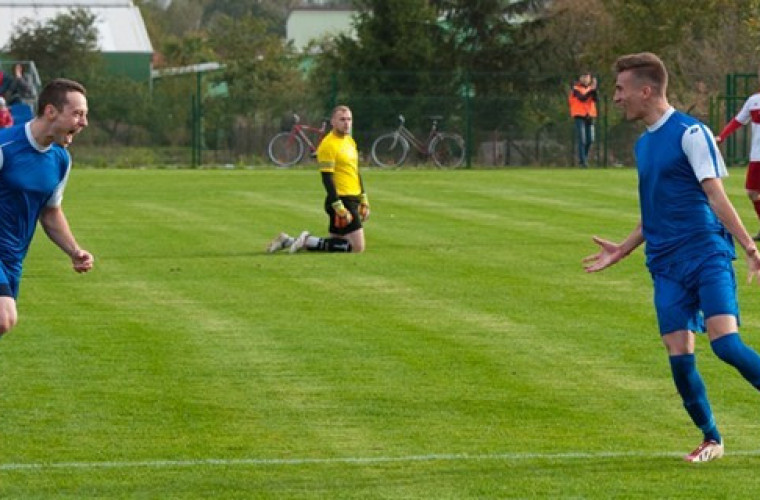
[583,52,760,462]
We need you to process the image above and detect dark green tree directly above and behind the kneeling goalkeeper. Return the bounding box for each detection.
[310,0,457,137]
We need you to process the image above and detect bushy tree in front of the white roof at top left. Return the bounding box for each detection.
[7,8,102,81]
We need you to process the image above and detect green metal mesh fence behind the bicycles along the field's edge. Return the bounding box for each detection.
[70,72,756,168]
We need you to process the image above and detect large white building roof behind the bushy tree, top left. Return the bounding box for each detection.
[0,0,153,53]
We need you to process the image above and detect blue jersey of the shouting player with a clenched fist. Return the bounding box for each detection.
[0,123,71,271]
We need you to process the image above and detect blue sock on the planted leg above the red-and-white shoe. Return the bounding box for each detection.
[670,354,721,443]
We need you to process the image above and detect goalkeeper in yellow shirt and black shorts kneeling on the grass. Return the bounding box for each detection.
[267,106,369,253]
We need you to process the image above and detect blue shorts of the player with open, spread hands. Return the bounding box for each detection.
[652,254,739,335]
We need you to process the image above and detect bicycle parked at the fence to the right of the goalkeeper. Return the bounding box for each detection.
[371,115,465,168]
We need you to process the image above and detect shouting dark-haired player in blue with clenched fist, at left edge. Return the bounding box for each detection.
[0,78,94,335]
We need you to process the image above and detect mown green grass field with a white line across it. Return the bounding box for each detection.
[0,169,760,499]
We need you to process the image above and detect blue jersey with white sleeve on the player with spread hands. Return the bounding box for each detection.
[635,108,735,271]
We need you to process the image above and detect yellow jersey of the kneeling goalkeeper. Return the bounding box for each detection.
[317,131,362,196]
